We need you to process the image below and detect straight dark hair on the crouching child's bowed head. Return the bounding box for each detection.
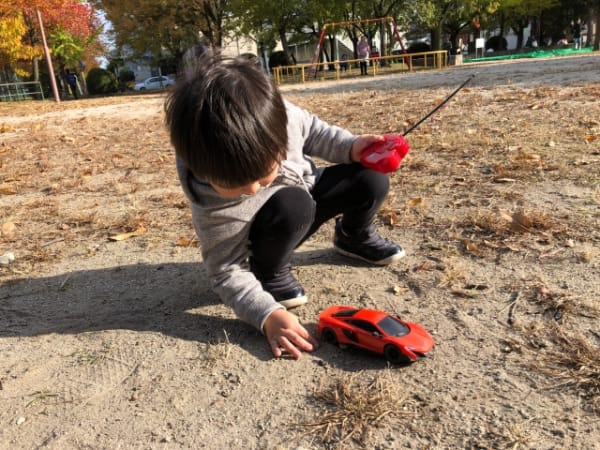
[165,52,287,188]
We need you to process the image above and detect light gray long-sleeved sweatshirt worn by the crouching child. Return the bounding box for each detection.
[177,102,356,331]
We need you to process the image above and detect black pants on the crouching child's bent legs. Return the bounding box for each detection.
[250,163,389,278]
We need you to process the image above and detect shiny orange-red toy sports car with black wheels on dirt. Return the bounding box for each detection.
[317,306,435,364]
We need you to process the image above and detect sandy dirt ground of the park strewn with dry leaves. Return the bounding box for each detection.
[0,54,600,450]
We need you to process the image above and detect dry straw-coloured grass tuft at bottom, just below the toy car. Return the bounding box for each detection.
[302,372,411,447]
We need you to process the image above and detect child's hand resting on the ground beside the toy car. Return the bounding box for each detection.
[263,309,319,359]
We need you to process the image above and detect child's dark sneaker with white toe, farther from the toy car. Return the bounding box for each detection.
[333,218,406,266]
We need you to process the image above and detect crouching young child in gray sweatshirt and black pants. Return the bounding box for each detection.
[165,54,404,358]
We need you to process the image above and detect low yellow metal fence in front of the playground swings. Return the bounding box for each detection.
[273,50,448,84]
